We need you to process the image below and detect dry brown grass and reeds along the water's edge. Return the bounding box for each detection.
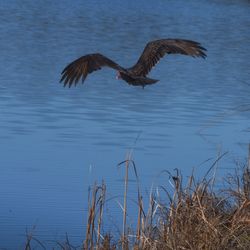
[23,151,250,250]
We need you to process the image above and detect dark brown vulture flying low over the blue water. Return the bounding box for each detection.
[60,39,207,88]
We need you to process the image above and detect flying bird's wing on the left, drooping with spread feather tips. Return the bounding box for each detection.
[60,53,124,87]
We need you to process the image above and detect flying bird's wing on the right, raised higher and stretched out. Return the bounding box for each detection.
[129,39,206,76]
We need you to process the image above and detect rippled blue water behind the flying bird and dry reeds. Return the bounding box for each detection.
[0,0,250,249]
